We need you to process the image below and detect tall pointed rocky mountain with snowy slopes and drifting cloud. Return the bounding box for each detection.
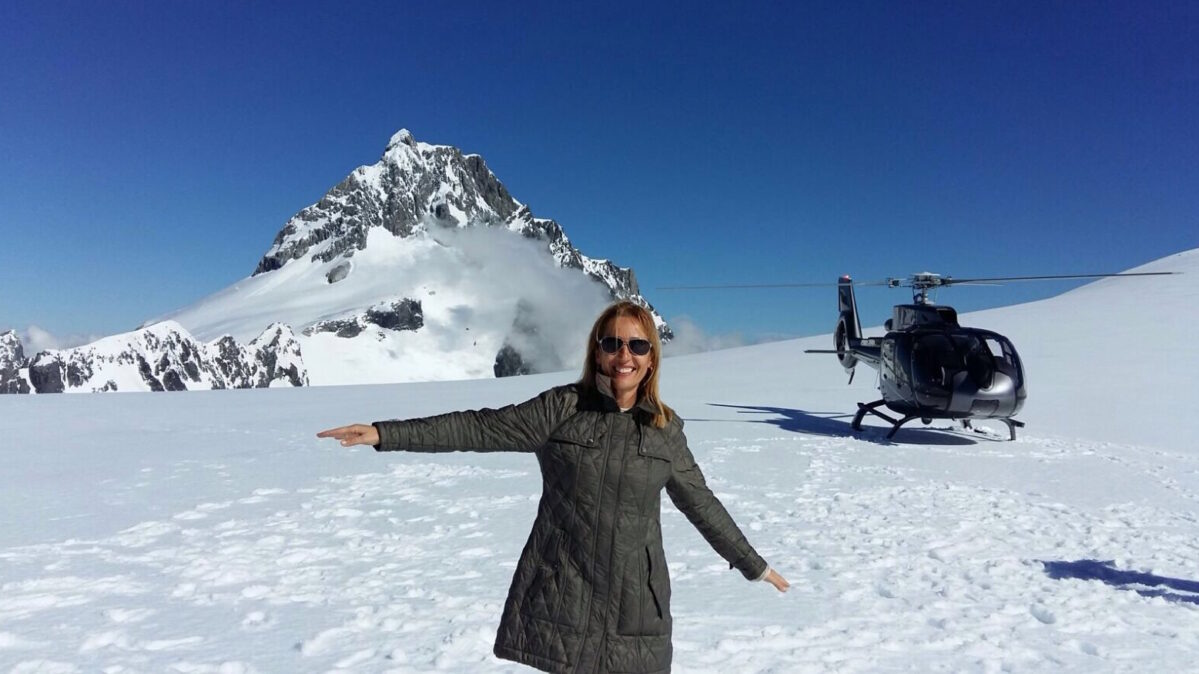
[153,130,673,384]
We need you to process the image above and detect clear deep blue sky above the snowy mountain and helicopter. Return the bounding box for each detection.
[0,1,1199,339]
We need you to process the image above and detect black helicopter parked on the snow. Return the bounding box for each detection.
[806,272,1173,440]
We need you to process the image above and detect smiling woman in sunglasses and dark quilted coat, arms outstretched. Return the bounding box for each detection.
[318,302,789,673]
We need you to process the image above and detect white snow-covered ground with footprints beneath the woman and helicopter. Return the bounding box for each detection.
[0,251,1199,674]
